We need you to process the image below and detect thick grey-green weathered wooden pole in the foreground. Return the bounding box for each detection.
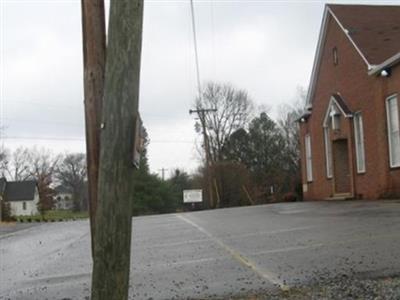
[91,0,143,300]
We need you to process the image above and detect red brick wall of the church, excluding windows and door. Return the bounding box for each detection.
[301,13,400,200]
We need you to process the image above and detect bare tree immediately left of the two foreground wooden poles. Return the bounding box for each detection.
[56,153,87,210]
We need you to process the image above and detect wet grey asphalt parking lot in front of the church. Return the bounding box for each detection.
[0,201,400,299]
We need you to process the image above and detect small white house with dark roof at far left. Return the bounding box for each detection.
[3,181,39,216]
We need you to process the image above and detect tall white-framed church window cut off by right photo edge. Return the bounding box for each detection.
[386,95,400,167]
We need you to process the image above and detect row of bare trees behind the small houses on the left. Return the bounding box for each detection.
[0,147,87,212]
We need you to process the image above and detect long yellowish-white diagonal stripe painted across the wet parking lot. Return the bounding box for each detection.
[176,214,288,290]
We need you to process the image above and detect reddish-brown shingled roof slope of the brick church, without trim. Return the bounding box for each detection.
[328,4,400,65]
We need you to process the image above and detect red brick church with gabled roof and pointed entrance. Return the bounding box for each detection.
[300,4,400,200]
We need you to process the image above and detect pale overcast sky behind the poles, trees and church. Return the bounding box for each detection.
[0,0,398,176]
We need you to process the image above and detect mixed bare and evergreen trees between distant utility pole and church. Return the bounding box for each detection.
[194,82,305,208]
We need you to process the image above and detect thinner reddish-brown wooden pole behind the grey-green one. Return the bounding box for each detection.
[81,0,106,255]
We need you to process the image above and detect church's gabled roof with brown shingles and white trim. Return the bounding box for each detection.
[307,4,400,106]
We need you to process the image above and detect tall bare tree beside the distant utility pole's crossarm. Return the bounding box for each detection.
[195,82,253,162]
